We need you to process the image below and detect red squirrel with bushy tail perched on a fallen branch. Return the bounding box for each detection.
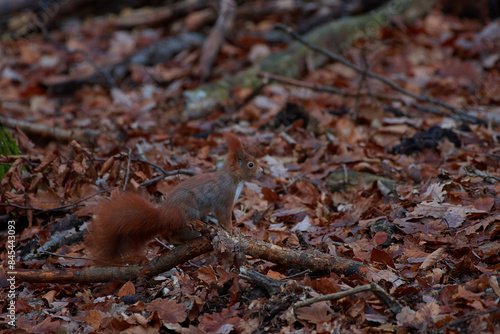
[85,132,262,262]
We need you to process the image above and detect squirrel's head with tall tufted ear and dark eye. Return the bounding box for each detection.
[223,132,262,182]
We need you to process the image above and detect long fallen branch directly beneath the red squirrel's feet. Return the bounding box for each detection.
[16,228,368,283]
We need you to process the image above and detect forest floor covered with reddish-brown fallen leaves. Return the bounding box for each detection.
[0,1,500,333]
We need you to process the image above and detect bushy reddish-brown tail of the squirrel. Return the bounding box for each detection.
[85,193,183,263]
